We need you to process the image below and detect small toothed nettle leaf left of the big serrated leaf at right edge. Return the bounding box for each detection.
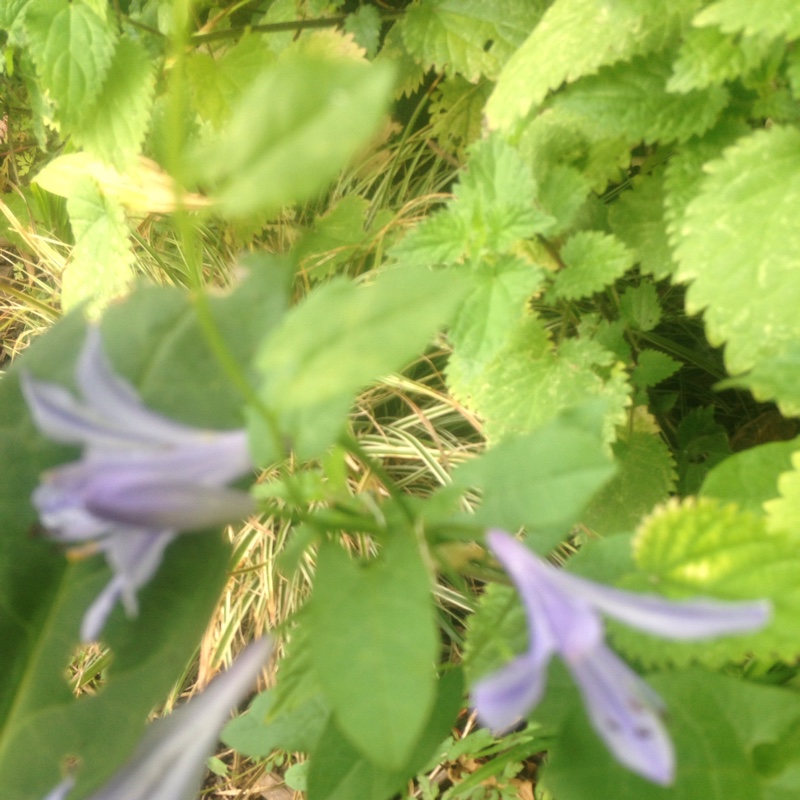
[548,231,635,300]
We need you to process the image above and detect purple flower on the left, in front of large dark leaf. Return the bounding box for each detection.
[22,326,253,641]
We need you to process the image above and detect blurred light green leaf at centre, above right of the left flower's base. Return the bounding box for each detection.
[256,267,463,459]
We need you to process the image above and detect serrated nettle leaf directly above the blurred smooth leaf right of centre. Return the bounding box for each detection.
[447,316,630,442]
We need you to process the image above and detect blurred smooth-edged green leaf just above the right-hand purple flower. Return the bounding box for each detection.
[453,404,614,553]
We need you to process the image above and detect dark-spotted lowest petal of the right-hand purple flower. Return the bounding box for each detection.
[567,644,675,786]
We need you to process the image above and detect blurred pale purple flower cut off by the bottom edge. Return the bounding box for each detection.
[45,638,272,800]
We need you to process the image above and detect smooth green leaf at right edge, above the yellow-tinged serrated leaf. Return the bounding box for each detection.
[700,439,800,516]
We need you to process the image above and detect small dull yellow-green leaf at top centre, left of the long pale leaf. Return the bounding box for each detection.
[428,75,492,154]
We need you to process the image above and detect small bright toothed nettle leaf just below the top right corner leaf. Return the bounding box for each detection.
[667,28,775,92]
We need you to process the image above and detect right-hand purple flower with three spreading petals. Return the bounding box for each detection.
[472,531,771,785]
